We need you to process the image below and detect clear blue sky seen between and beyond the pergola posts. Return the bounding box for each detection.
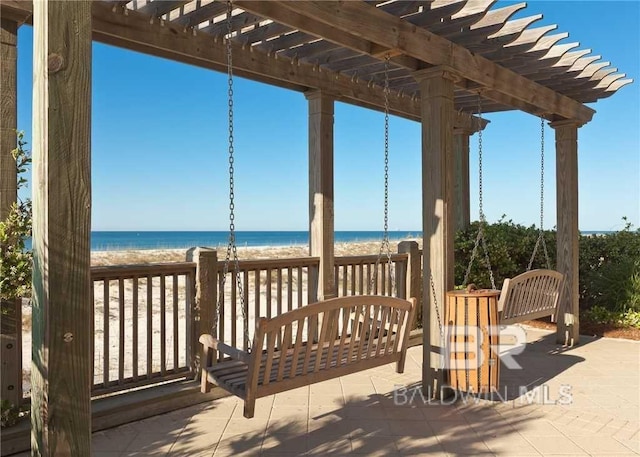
[18,1,640,231]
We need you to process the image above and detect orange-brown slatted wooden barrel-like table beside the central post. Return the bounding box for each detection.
[445,289,500,393]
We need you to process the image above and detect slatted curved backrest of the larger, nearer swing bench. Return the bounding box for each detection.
[247,295,416,392]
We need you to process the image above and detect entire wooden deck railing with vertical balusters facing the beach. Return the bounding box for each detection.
[57,242,421,396]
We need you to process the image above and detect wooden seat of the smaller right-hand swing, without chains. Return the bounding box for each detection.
[498,269,564,324]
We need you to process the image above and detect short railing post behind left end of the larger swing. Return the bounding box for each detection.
[187,248,218,376]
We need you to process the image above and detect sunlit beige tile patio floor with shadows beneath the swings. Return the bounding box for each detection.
[11,329,640,457]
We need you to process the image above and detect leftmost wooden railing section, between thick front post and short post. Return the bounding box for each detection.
[91,262,196,396]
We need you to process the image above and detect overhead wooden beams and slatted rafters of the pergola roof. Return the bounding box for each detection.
[2,0,630,122]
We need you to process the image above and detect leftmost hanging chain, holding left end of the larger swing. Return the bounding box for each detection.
[212,0,252,350]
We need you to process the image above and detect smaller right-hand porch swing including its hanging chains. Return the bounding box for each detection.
[463,94,564,324]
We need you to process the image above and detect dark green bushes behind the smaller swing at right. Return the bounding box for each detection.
[455,216,640,314]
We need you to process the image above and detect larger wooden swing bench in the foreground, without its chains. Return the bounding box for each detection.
[200,295,416,418]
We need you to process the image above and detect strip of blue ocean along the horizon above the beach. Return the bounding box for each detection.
[86,231,422,251]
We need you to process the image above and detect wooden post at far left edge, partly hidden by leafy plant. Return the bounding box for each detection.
[0,18,22,406]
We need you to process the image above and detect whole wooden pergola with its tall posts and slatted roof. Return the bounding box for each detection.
[0,0,631,455]
